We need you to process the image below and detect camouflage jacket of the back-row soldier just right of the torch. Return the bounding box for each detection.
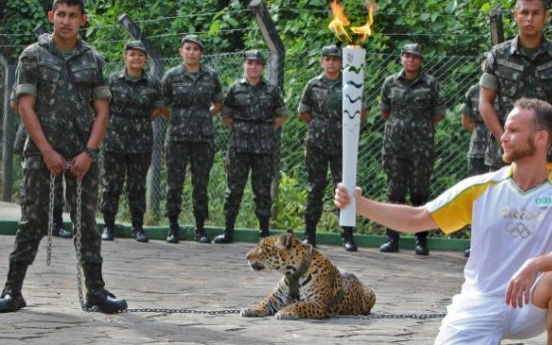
[380,71,446,158]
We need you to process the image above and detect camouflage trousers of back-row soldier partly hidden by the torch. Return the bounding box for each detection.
[303,146,343,224]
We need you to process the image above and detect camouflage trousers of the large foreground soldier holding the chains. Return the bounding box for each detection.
[10,156,103,264]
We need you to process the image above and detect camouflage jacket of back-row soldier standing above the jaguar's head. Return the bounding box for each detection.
[221,78,287,154]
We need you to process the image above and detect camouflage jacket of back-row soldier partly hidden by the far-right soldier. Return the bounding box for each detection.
[460,84,489,158]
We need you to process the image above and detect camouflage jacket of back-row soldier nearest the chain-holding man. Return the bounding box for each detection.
[103,69,163,153]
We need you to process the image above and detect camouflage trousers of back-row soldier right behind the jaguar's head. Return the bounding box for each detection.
[224,149,274,219]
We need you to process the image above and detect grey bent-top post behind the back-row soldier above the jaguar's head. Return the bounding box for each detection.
[249,0,286,227]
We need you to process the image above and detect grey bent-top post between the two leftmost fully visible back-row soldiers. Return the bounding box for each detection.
[118,14,167,220]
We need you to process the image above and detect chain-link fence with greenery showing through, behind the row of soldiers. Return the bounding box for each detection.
[0,51,481,232]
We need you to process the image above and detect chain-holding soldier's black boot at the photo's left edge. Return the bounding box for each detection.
[0,262,29,313]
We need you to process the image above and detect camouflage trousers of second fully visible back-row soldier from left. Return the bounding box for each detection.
[165,142,215,220]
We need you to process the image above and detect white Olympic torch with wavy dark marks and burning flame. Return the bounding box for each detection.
[328,0,376,226]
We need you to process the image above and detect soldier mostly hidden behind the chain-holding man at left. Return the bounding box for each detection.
[10,85,73,238]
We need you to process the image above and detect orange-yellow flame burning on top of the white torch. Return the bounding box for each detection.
[328,0,377,45]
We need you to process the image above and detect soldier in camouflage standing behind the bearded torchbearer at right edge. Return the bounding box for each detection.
[479,0,552,170]
